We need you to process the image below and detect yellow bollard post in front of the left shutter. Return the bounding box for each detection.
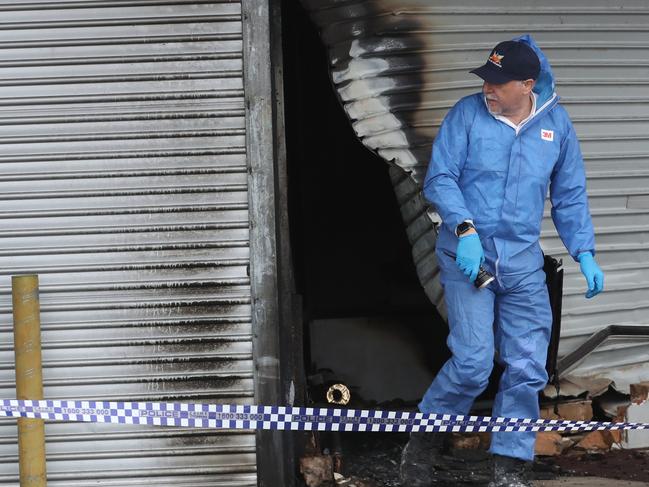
[11,275,47,487]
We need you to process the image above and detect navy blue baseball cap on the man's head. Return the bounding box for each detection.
[471,41,541,85]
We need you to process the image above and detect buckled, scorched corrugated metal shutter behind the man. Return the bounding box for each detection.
[303,0,649,388]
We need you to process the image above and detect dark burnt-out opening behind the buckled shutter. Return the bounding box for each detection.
[282,2,449,406]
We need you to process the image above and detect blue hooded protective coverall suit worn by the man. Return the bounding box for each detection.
[419,36,595,460]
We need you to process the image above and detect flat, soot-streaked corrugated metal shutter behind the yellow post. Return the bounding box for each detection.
[0,0,256,487]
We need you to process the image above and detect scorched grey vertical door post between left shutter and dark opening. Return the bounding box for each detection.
[242,0,304,487]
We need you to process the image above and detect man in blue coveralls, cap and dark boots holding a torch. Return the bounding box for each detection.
[401,36,604,487]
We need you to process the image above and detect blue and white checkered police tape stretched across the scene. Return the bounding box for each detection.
[0,399,649,432]
